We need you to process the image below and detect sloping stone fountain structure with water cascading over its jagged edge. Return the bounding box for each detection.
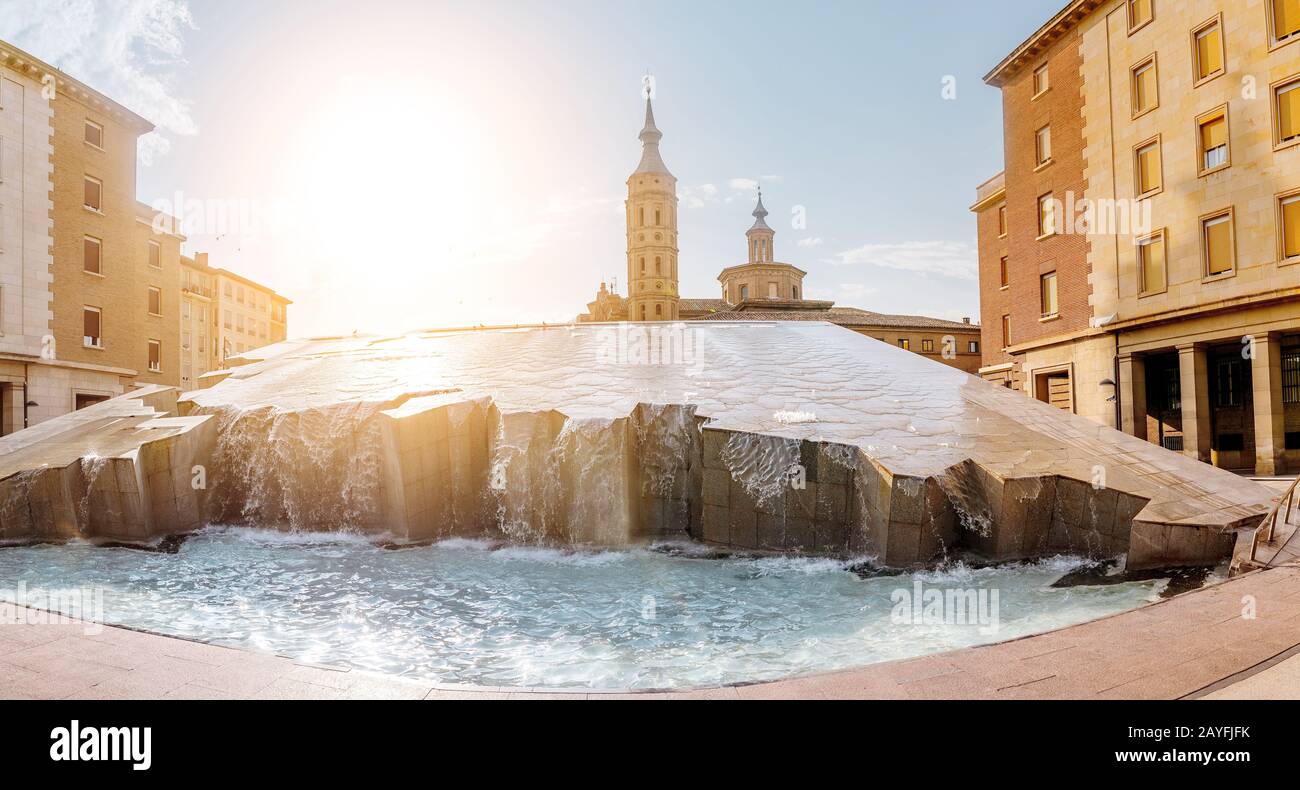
[0,322,1270,569]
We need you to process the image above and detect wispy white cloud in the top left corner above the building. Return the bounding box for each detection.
[0,0,199,165]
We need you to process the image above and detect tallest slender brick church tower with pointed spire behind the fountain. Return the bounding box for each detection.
[627,91,680,321]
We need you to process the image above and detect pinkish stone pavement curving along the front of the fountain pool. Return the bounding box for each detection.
[0,567,1300,700]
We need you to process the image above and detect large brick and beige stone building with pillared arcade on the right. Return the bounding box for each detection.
[972,0,1300,474]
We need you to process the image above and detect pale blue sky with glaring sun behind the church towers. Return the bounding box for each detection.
[0,0,1063,337]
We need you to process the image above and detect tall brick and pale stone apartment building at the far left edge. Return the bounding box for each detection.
[0,43,183,433]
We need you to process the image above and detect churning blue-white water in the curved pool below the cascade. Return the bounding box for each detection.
[0,528,1160,689]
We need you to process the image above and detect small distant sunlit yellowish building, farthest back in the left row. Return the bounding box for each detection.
[212,269,293,368]
